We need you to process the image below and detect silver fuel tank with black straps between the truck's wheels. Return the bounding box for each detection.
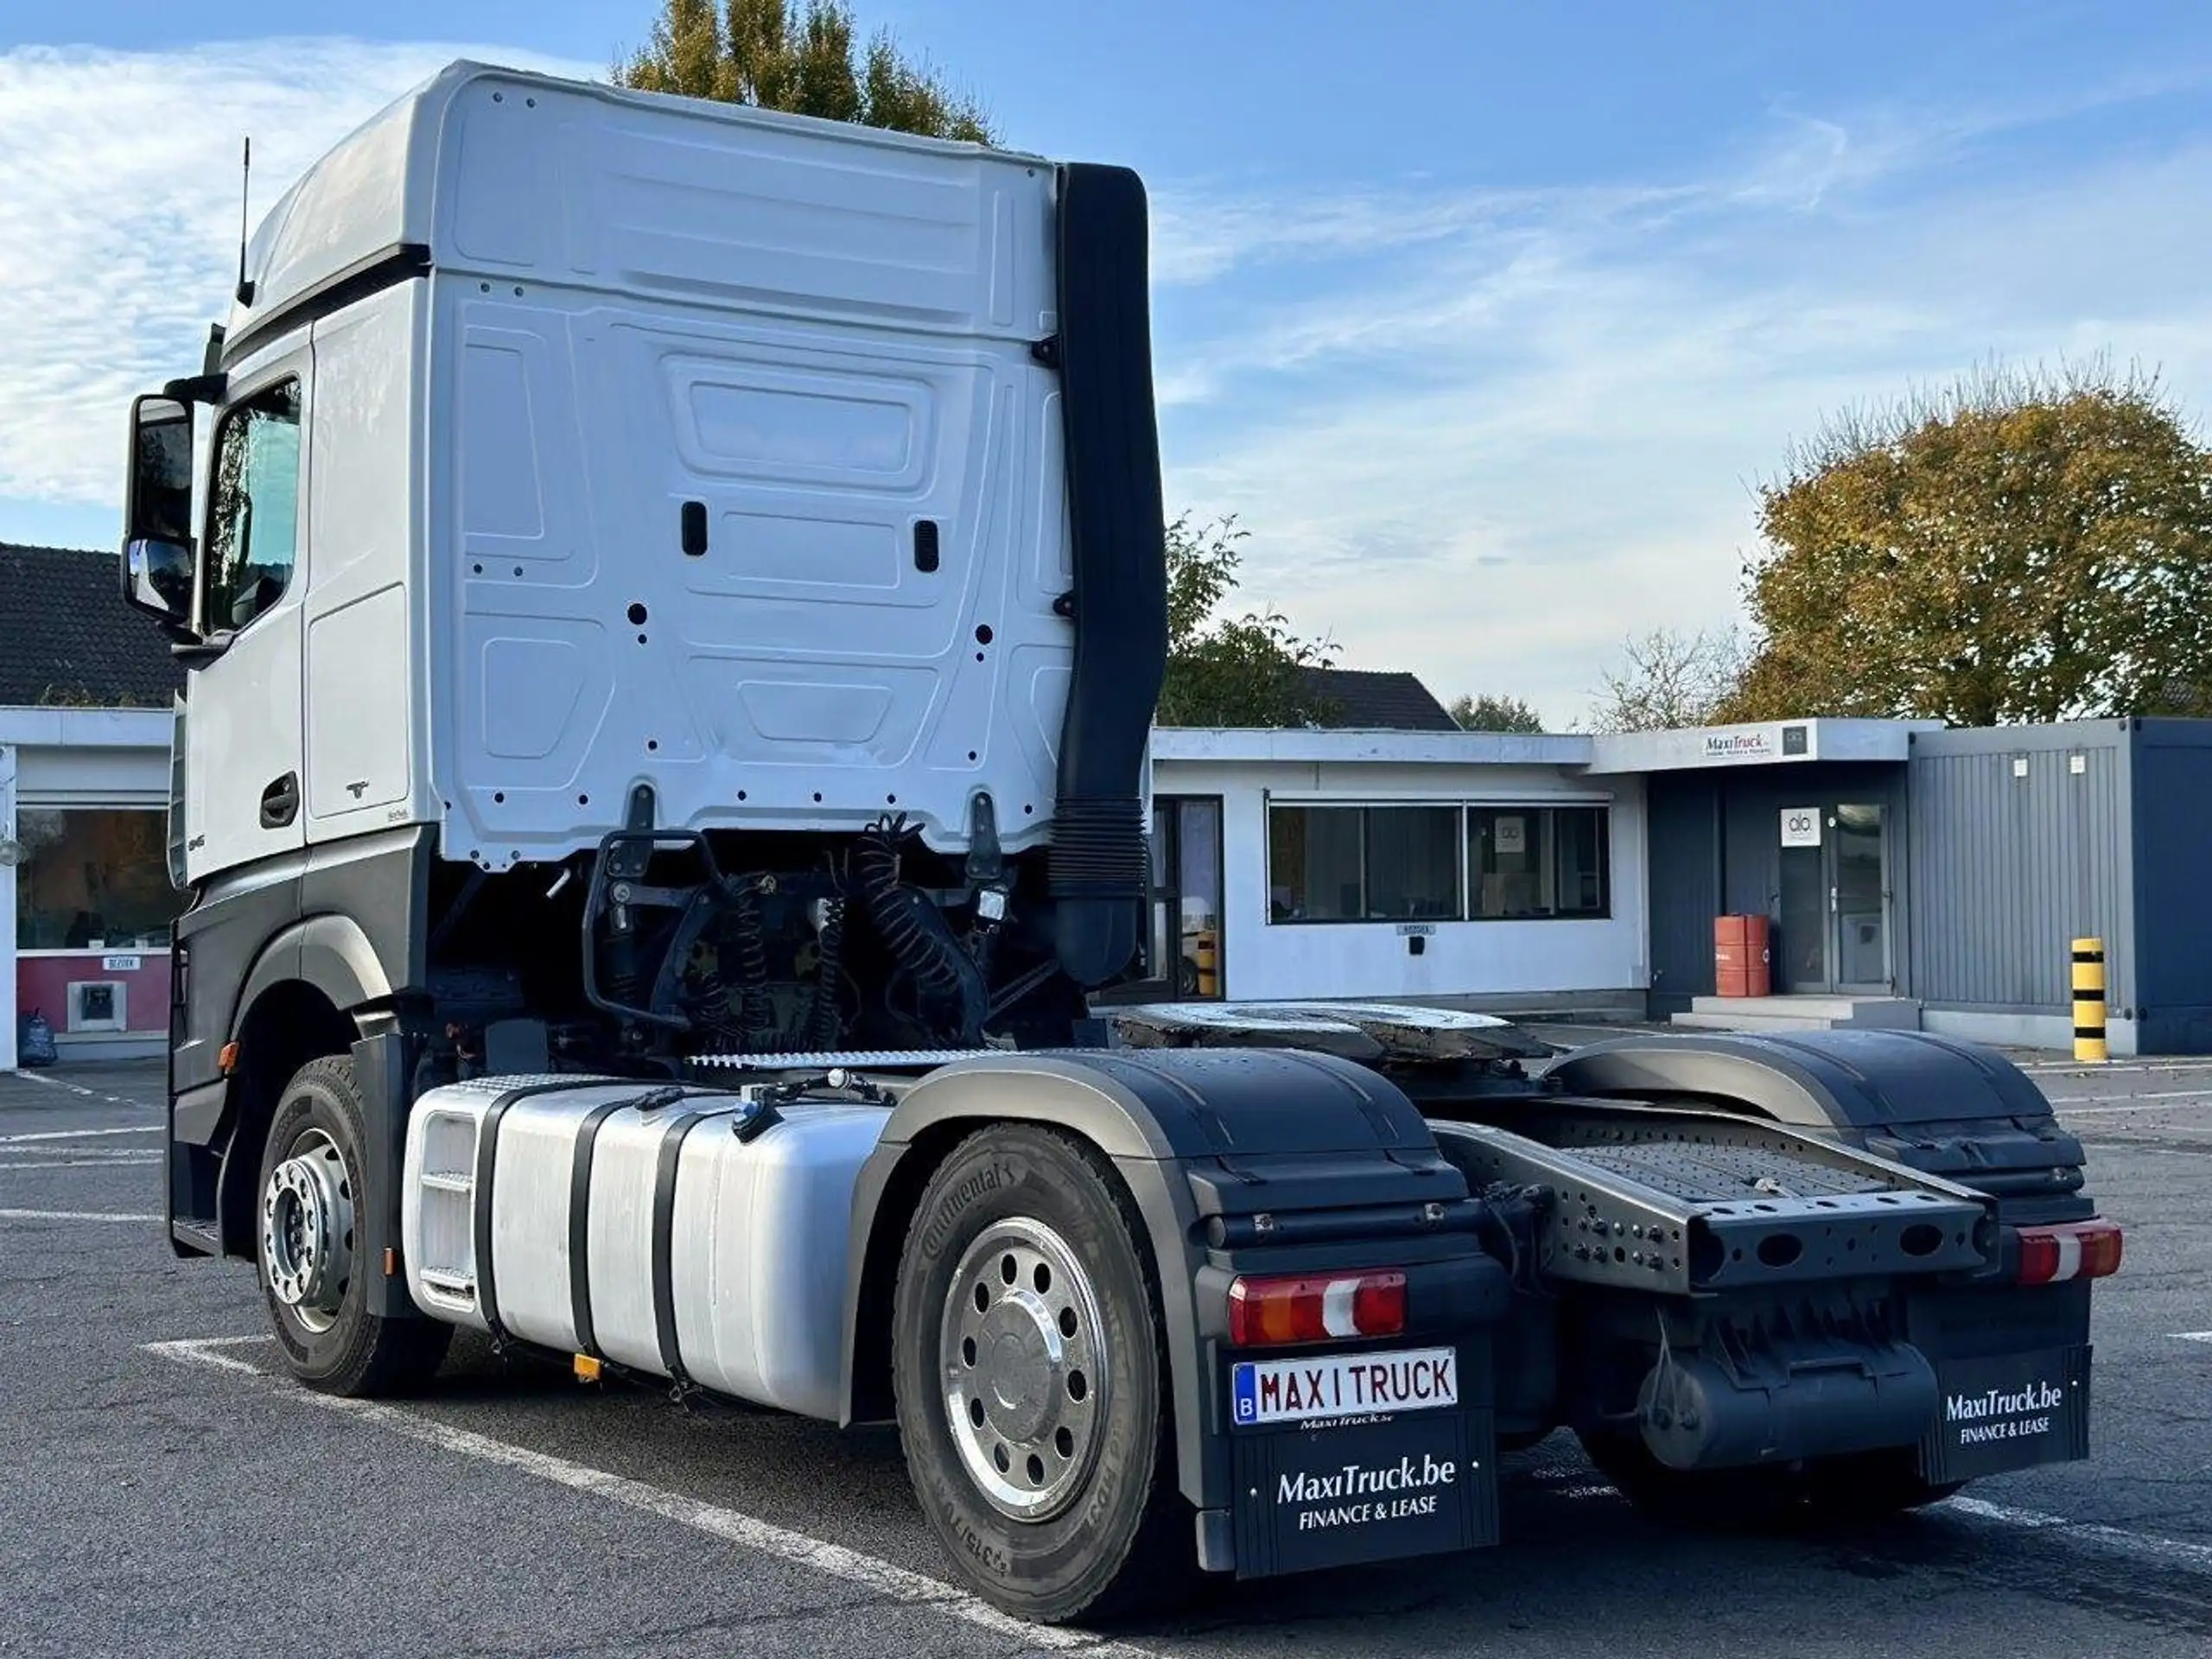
[400,1077,892,1421]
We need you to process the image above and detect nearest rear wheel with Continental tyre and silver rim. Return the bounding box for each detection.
[892,1123,1197,1624]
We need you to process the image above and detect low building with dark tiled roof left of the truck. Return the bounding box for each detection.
[0,544,183,1071]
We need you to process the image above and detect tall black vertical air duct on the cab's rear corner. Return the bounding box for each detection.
[1038,163,1168,987]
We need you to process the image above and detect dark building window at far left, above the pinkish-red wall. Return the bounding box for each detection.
[16,807,181,951]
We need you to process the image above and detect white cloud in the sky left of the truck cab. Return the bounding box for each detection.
[0,40,600,519]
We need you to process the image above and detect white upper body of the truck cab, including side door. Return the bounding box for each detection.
[131,64,1115,898]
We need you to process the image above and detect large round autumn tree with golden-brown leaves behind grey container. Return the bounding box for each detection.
[1723,363,2212,726]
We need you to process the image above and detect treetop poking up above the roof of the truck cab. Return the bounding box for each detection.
[615,0,993,143]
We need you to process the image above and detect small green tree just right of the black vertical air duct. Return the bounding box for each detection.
[1157,518,1336,726]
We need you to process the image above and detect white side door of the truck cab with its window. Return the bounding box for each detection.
[183,336,315,880]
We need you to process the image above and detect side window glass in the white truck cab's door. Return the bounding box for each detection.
[204,380,299,632]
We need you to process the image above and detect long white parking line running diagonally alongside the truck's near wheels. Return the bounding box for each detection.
[146,1336,1153,1659]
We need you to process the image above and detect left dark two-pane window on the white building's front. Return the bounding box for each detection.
[1268,805,1462,923]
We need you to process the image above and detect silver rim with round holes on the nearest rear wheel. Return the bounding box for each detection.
[938,1217,1113,1522]
